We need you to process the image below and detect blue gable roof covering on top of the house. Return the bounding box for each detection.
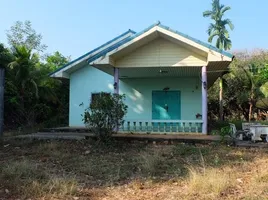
[49,22,234,77]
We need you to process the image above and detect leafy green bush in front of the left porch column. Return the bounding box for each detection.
[83,92,127,140]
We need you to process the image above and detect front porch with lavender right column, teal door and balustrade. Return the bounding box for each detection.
[93,66,208,134]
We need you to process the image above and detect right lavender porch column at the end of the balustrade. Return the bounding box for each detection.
[202,66,208,134]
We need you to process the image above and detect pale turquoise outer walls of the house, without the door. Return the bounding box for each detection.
[69,66,202,126]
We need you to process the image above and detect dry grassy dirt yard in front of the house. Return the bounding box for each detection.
[0,139,268,200]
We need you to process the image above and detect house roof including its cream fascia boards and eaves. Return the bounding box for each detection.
[50,22,233,78]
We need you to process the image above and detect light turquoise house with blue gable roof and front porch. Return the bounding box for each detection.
[50,23,233,134]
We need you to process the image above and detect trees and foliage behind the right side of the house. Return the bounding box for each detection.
[209,50,268,120]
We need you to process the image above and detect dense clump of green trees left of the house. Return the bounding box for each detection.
[0,21,70,129]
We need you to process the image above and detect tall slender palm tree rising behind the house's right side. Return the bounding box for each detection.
[203,0,234,120]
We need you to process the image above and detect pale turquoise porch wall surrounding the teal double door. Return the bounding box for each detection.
[120,77,202,120]
